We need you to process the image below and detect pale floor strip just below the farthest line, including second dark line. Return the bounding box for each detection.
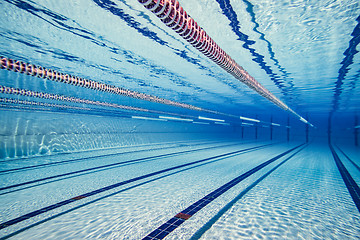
[0,139,253,196]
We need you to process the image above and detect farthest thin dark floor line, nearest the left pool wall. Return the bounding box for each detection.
[0,140,228,173]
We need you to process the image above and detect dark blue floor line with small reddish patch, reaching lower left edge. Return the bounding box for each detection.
[2,140,278,237]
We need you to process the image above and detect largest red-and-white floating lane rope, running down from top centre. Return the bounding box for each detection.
[138,0,313,126]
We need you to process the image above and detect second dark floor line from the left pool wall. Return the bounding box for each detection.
[0,143,258,192]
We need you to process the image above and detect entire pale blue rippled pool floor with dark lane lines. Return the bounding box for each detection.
[0,140,360,239]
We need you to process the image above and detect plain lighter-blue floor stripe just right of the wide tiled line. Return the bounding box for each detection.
[189,144,308,240]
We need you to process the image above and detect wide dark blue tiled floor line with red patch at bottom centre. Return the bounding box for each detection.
[143,144,304,240]
